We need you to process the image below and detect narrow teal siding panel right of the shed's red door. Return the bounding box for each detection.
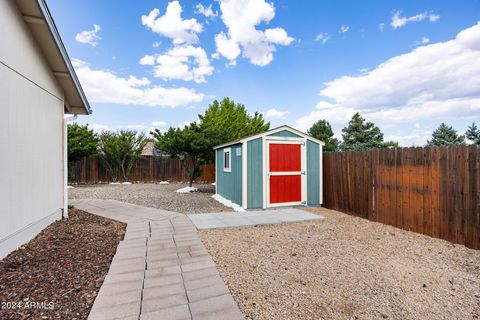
[307,140,322,205]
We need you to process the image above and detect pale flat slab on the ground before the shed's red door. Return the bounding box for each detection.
[188,208,325,230]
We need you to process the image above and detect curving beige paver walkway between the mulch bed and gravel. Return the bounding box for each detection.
[71,200,244,320]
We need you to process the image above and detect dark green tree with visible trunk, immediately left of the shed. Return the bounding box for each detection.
[152,122,218,187]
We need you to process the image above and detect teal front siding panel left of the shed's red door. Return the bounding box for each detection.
[247,138,263,209]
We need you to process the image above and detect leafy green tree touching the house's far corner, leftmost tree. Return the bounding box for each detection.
[67,123,98,178]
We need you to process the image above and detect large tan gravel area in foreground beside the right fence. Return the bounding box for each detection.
[200,209,480,320]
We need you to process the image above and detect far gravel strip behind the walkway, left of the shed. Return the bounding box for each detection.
[68,183,232,213]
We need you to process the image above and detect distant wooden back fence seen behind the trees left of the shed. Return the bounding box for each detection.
[70,156,215,184]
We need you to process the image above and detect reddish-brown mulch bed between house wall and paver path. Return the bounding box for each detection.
[0,209,125,320]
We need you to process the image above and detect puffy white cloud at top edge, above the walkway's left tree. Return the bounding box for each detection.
[142,1,203,44]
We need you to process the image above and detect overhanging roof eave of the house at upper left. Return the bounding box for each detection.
[15,0,92,114]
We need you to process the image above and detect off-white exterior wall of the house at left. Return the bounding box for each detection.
[0,1,64,258]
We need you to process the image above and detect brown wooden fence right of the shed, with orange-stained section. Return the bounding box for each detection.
[323,146,480,249]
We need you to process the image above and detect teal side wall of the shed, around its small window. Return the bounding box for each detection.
[215,144,242,206]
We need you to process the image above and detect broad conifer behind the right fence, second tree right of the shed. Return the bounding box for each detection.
[340,112,398,151]
